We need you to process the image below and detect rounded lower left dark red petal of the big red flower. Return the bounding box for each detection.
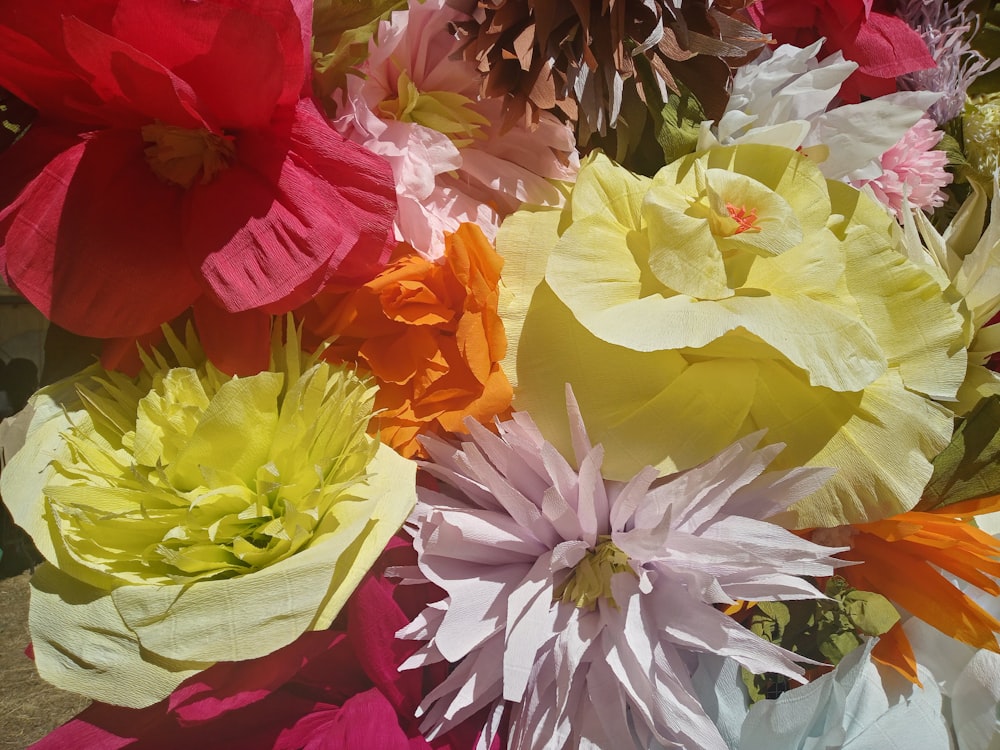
[0,130,199,338]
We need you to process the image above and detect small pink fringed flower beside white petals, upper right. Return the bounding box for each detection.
[851,117,952,221]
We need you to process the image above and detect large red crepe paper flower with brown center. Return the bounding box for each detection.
[0,0,395,374]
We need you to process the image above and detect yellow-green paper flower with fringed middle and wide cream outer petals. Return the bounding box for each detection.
[0,320,415,706]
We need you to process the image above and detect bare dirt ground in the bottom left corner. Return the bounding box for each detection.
[0,572,90,750]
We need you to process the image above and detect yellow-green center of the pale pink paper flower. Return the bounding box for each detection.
[378,70,489,148]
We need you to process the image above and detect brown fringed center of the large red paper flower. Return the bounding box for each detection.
[142,122,236,188]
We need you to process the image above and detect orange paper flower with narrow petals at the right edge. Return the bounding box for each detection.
[812,495,1000,684]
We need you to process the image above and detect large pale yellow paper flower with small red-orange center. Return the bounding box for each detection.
[497,145,966,527]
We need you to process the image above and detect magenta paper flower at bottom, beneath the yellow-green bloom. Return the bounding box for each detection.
[33,537,499,750]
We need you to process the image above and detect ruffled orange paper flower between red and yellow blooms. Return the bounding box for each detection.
[300,224,513,457]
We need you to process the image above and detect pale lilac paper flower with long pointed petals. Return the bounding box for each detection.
[400,388,839,750]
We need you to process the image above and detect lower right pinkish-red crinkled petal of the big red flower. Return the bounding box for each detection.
[183,100,395,312]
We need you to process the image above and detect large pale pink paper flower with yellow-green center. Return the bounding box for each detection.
[334,0,579,258]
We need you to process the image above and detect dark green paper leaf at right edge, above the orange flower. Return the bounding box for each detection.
[915,395,1000,511]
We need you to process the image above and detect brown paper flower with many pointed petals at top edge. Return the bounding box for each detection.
[458,0,765,137]
